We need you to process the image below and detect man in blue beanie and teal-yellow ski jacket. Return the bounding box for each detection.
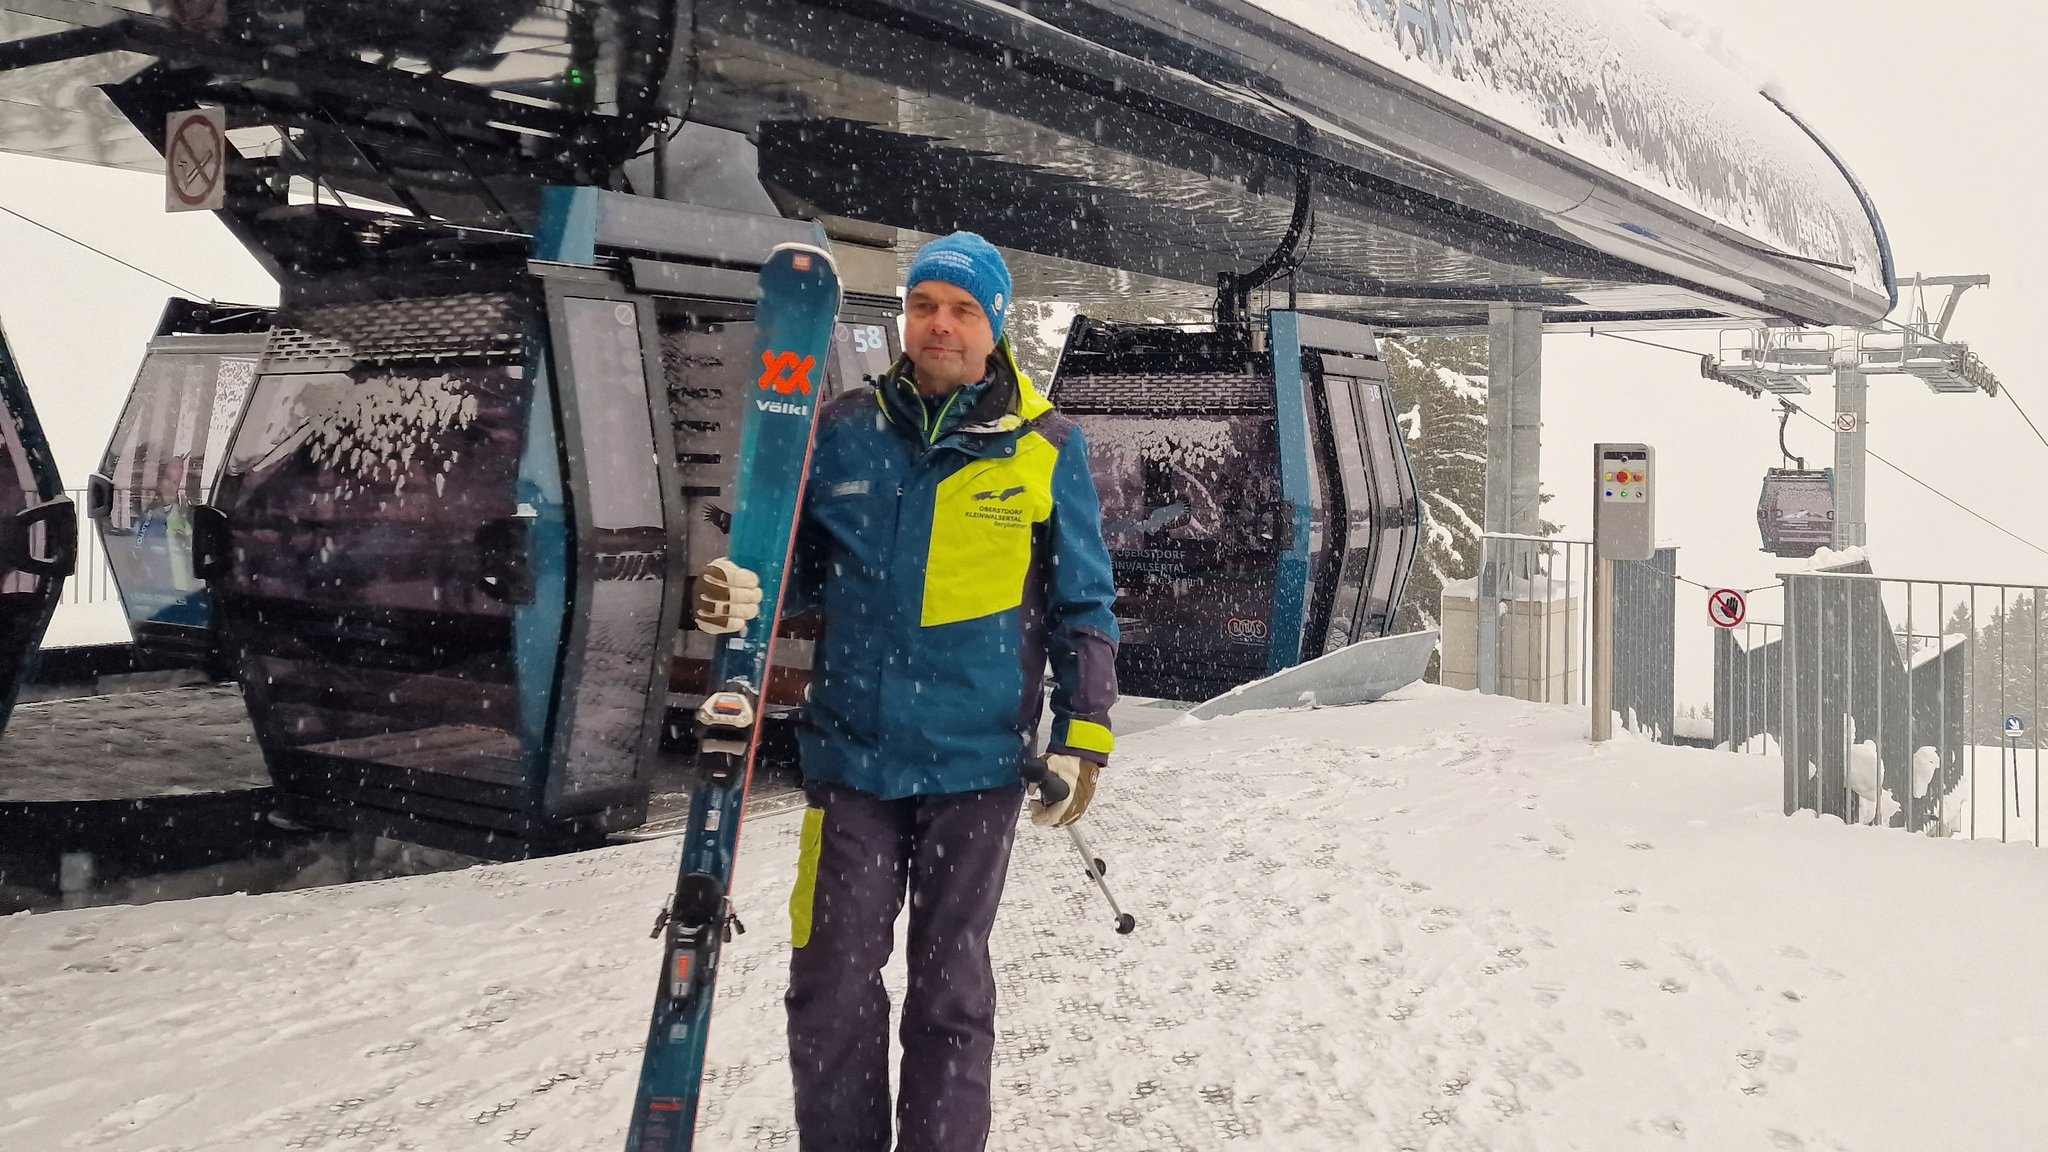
[696,232,1116,1152]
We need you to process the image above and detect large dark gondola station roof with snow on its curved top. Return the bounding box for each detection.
[0,0,1894,328]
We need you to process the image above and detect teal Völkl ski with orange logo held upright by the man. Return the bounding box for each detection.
[627,244,840,1152]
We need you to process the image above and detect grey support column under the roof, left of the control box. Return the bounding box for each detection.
[1477,303,1542,695]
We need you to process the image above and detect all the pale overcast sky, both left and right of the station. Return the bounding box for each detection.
[0,0,2048,664]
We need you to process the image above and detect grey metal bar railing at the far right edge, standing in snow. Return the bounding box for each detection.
[1774,572,2048,845]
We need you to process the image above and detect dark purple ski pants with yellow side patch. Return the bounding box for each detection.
[786,783,1024,1152]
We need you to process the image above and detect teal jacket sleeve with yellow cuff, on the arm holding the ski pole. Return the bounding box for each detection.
[1047,424,1118,765]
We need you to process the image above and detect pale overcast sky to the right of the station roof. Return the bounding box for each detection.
[1544,0,2048,590]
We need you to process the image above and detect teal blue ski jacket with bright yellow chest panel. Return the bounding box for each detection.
[786,340,1116,799]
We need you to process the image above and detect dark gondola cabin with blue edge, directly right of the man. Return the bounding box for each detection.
[1051,312,1421,701]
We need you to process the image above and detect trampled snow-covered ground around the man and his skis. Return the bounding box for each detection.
[0,689,2048,1152]
